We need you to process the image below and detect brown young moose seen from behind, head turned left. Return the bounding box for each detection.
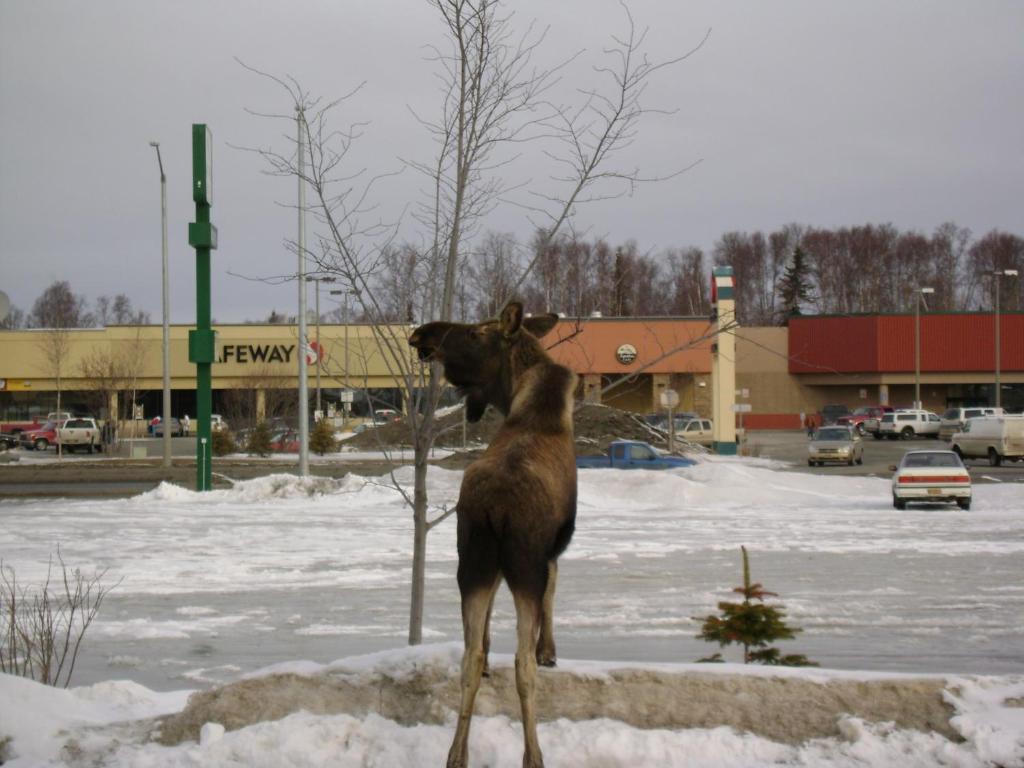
[409,303,577,768]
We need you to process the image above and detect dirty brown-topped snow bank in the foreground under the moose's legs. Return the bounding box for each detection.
[0,643,1024,768]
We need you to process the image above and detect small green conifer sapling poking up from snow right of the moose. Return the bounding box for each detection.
[697,547,817,667]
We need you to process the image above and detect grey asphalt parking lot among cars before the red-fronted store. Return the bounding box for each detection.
[742,431,1024,482]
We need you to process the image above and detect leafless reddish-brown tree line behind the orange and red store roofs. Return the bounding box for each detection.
[329,223,1024,326]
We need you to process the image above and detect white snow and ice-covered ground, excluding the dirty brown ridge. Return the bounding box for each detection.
[0,458,1024,766]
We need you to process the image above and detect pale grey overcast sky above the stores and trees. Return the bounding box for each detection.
[0,0,1024,324]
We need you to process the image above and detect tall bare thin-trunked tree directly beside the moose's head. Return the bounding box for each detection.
[241,0,704,644]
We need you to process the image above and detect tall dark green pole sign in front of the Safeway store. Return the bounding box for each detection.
[188,123,217,490]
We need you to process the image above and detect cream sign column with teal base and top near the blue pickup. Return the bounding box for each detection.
[711,266,736,456]
